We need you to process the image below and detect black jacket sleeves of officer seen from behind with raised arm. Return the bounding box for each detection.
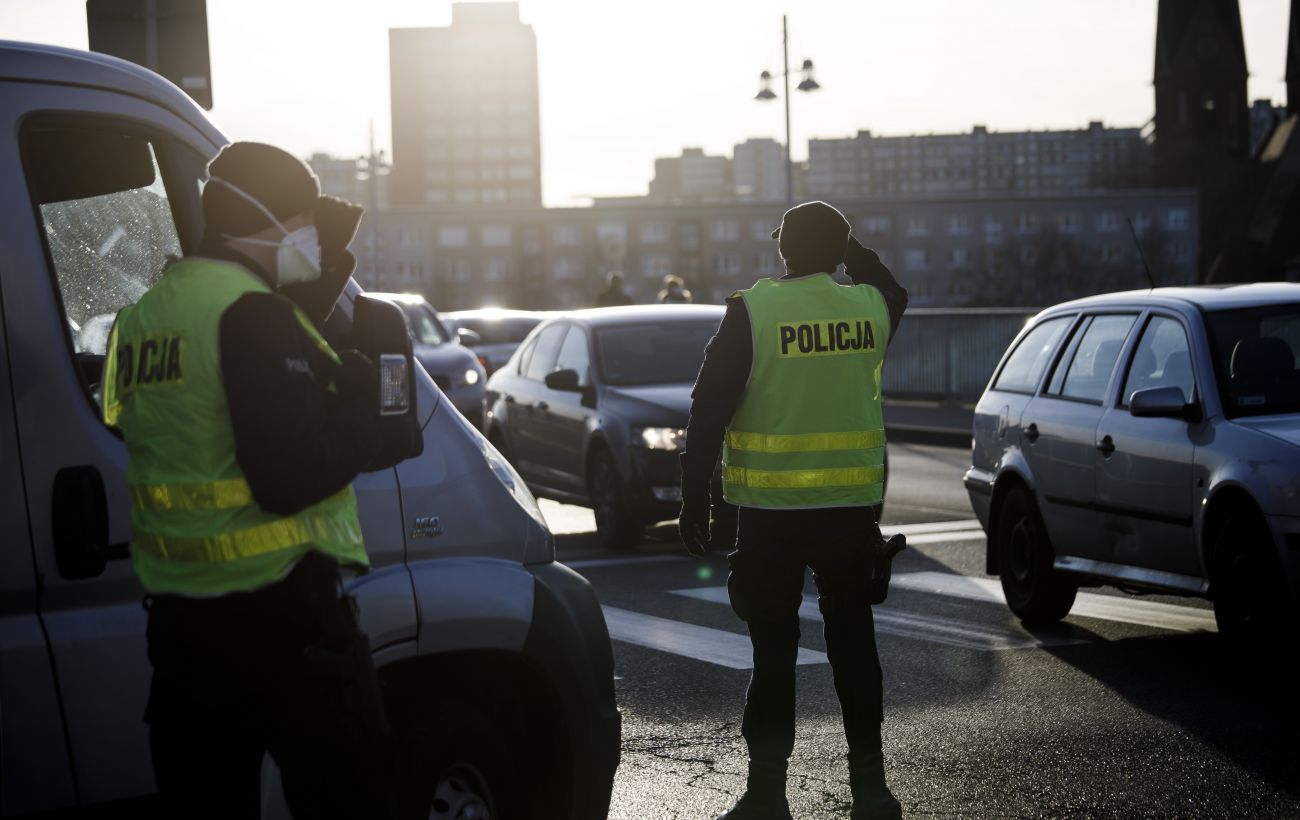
[681,247,907,500]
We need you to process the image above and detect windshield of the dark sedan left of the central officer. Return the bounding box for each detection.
[595,321,718,387]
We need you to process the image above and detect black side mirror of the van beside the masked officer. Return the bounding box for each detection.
[352,295,424,472]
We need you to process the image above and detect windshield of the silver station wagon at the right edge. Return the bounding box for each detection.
[1206,304,1300,418]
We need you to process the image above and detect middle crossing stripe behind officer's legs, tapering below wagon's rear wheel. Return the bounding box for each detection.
[670,586,1088,652]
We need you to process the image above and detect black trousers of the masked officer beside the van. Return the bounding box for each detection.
[144,552,391,820]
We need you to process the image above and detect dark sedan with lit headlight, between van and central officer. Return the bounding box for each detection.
[484,305,723,548]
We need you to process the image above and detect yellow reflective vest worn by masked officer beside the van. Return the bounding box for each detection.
[104,259,369,596]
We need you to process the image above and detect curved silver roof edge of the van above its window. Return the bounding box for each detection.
[0,40,220,146]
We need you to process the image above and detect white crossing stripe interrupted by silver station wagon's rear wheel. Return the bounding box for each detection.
[891,572,1218,632]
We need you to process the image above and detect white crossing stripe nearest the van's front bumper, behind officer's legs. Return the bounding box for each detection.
[601,607,828,669]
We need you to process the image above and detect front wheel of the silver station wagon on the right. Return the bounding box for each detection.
[1210,503,1290,648]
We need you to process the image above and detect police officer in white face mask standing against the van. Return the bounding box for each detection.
[104,143,389,819]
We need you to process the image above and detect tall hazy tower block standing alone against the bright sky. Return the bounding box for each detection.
[389,3,542,208]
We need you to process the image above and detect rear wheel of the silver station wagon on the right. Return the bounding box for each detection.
[996,487,1079,624]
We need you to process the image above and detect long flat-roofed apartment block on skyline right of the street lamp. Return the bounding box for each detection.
[807,122,1151,199]
